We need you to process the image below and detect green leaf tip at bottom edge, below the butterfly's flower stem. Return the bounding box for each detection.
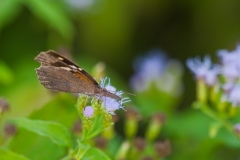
[82,148,110,160]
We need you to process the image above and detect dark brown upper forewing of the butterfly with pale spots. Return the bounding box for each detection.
[35,50,98,86]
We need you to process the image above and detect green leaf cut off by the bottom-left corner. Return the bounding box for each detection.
[0,149,29,160]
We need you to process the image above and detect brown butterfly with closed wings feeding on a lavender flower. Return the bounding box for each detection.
[34,50,122,101]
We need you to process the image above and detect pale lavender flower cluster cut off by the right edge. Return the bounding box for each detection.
[187,45,240,106]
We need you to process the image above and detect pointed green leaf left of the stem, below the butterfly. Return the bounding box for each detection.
[11,118,72,147]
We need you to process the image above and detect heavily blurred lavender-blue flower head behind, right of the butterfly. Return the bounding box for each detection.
[130,49,182,93]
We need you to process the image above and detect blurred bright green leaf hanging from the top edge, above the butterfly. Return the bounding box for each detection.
[26,0,73,40]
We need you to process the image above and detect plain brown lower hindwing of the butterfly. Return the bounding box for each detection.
[36,66,94,95]
